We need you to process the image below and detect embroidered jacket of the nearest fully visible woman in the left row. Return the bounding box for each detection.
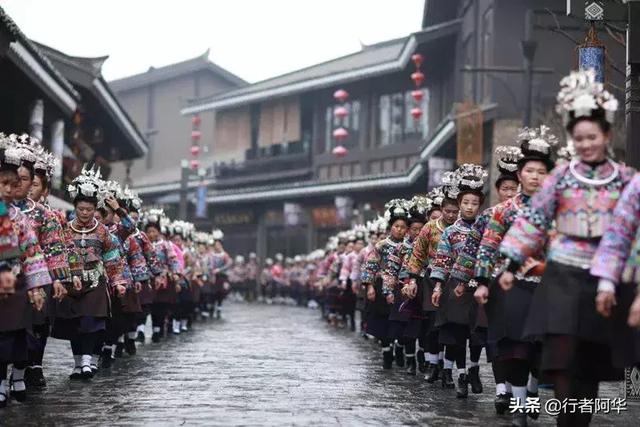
[65,220,127,286]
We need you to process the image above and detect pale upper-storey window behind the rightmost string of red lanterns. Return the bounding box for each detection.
[377,89,429,146]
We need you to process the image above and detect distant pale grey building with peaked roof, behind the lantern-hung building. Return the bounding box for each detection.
[110,50,246,190]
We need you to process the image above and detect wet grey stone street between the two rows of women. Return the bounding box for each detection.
[0,304,640,426]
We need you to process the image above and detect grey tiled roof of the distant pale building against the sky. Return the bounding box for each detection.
[110,50,247,92]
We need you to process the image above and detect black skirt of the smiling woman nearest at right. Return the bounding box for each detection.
[524,261,623,381]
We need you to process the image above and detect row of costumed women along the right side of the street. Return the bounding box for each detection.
[232,71,640,426]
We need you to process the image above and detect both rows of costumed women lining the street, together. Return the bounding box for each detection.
[0,71,640,426]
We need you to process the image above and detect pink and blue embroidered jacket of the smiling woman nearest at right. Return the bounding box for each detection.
[500,162,633,269]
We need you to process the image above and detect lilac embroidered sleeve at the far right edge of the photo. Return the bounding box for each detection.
[591,174,640,283]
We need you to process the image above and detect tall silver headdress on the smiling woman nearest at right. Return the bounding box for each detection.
[556,69,618,125]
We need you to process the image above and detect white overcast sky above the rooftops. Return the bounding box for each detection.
[0,0,424,82]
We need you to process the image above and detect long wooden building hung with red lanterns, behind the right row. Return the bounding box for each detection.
[134,0,623,256]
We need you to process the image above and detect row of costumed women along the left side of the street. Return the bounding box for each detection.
[0,134,232,408]
